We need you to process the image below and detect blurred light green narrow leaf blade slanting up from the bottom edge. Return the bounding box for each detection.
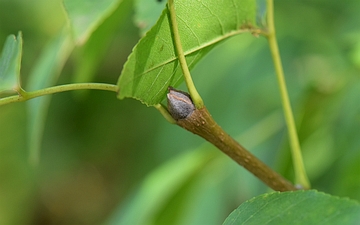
[106,149,214,225]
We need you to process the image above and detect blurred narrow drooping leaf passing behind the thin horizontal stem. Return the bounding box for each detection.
[27,29,74,164]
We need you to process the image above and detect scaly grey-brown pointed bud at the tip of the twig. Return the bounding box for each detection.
[167,87,195,120]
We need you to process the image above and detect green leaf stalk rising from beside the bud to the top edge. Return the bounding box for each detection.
[168,0,204,109]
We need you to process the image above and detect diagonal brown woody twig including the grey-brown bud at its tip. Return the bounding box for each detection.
[167,87,297,191]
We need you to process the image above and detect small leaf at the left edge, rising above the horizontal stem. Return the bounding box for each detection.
[0,32,22,92]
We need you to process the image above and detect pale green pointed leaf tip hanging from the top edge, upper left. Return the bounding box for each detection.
[64,0,121,44]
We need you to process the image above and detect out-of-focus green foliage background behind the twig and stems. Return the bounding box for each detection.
[0,0,360,224]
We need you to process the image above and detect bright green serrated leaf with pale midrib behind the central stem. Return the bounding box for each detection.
[118,0,256,106]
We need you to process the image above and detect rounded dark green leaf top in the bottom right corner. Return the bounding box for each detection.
[224,190,360,225]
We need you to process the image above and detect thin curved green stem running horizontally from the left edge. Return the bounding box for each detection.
[0,83,118,106]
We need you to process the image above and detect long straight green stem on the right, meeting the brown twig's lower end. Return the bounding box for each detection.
[266,0,310,188]
